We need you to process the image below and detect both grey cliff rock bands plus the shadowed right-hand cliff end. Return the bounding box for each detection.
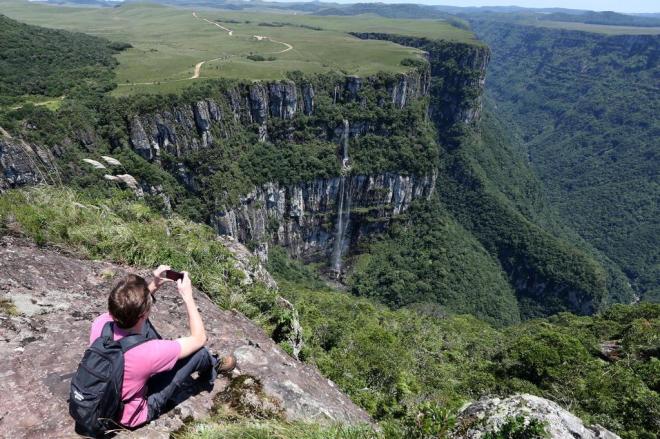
[121,38,489,272]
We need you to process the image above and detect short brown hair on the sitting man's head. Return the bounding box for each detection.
[108,274,151,329]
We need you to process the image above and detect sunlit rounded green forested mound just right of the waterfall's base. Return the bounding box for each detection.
[348,200,520,325]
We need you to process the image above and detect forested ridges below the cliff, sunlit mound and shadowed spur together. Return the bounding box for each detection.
[349,102,620,324]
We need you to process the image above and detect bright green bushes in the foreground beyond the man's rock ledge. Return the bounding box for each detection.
[270,246,660,438]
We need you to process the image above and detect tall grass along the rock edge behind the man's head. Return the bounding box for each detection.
[0,186,274,318]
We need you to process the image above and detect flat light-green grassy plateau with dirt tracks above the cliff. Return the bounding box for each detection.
[0,0,476,95]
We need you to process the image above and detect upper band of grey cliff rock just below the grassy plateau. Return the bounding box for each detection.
[128,69,430,161]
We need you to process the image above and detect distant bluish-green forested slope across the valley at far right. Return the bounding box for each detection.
[473,21,660,300]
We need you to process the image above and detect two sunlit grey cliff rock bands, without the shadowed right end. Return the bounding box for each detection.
[127,68,444,270]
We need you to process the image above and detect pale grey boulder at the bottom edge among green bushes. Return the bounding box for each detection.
[451,394,620,439]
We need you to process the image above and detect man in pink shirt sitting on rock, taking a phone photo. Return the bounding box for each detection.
[89,265,236,428]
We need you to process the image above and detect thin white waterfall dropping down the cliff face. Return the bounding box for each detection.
[331,119,352,278]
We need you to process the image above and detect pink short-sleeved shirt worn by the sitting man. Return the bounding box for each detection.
[89,313,181,427]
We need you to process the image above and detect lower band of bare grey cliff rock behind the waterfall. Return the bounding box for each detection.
[213,173,436,260]
